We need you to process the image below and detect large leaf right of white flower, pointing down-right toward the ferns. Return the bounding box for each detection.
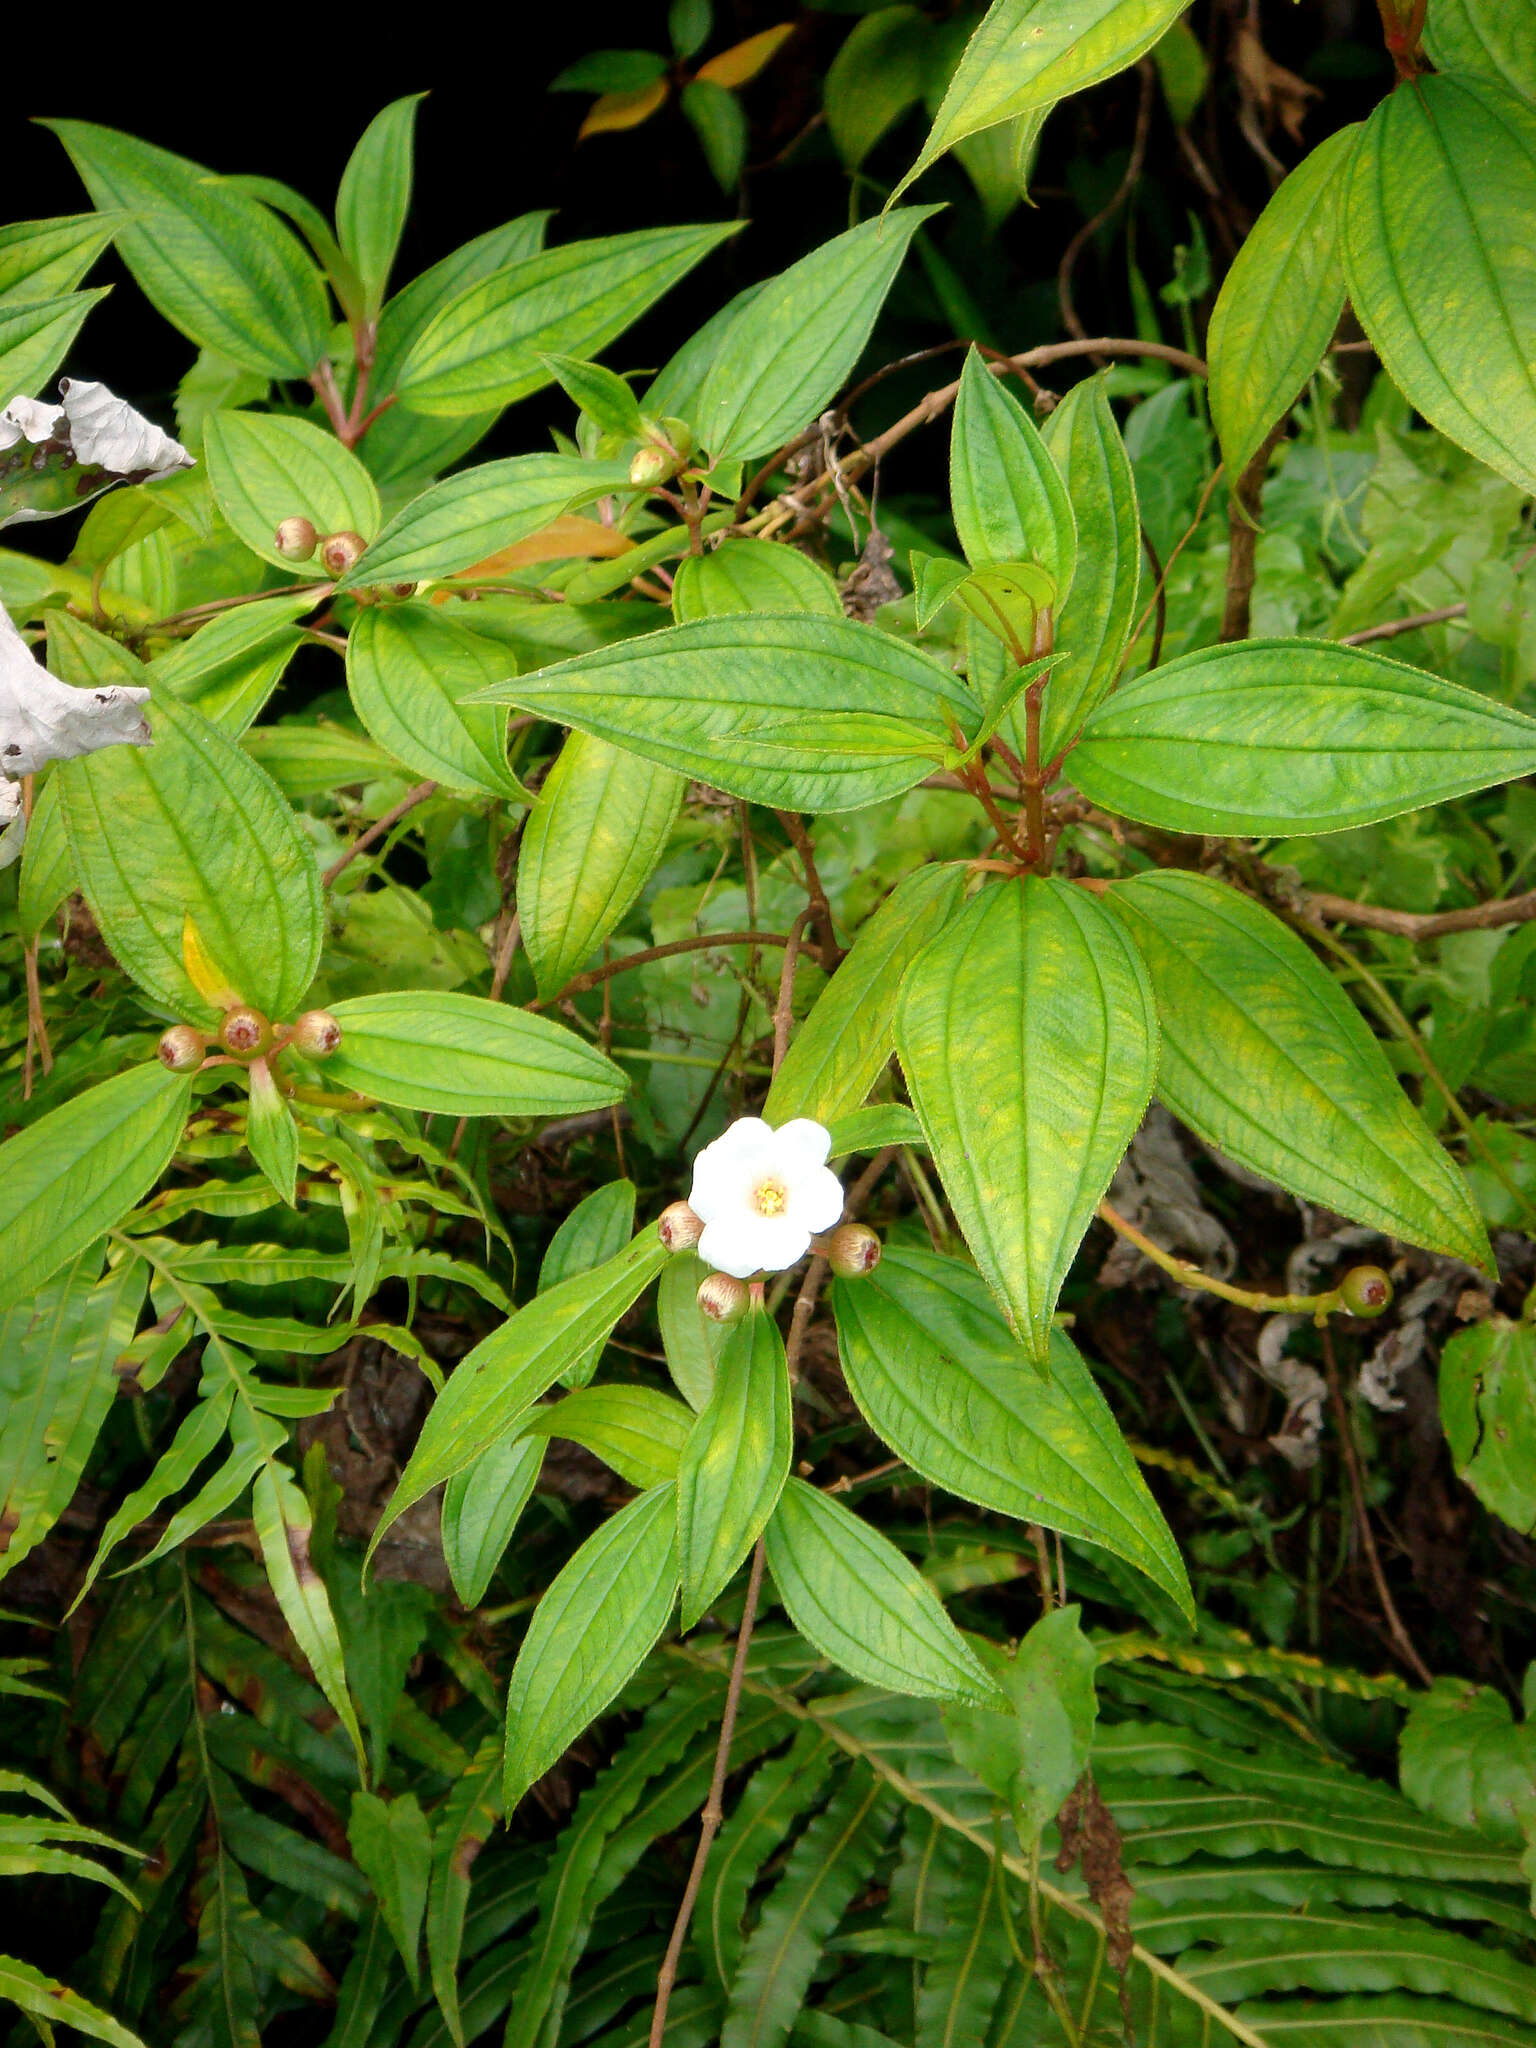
[831,1245,1194,1614]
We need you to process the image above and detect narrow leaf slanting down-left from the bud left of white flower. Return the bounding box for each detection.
[369,1229,668,1554]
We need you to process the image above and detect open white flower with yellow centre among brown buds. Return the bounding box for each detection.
[688,1116,842,1280]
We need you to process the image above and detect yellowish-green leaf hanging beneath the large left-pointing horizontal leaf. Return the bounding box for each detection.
[518,733,686,997]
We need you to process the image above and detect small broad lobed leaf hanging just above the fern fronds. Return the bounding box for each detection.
[944,1608,1098,1851]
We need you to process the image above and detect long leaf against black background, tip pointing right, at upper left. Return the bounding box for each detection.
[395,221,741,416]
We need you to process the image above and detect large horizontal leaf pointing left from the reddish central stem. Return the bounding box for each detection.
[473,612,975,811]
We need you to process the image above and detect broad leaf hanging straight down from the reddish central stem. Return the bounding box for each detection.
[895,877,1157,1368]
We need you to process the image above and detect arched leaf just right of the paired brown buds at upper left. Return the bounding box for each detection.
[342,455,631,590]
